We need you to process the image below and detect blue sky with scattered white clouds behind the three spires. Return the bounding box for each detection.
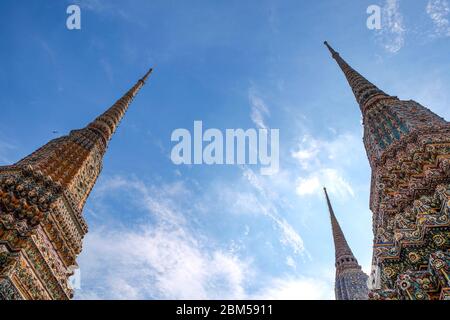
[0,0,450,299]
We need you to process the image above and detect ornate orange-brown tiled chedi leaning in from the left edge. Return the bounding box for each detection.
[0,69,152,300]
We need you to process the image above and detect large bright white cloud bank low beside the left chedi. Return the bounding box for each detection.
[77,226,249,299]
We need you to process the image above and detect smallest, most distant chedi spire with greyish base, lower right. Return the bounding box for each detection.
[323,188,369,300]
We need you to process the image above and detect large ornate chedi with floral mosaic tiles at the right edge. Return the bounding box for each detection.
[325,42,450,300]
